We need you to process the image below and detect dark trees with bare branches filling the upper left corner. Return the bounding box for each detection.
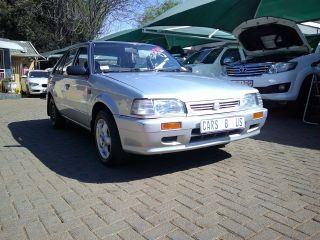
[0,0,143,52]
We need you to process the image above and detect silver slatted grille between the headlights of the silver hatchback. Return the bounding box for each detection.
[190,100,240,112]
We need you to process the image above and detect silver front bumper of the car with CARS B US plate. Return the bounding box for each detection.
[115,108,268,155]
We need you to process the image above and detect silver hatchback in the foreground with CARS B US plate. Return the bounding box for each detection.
[47,42,267,164]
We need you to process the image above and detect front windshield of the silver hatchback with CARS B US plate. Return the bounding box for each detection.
[93,42,185,73]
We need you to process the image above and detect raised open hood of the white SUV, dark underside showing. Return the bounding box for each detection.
[232,17,311,56]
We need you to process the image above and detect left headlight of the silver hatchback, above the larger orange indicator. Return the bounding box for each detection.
[131,99,186,117]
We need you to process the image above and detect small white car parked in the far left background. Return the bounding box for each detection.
[21,70,49,96]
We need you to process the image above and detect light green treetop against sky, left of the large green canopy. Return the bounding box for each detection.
[138,0,181,27]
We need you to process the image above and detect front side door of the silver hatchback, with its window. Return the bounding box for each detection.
[65,46,91,127]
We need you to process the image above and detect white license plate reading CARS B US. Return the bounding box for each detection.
[200,117,245,133]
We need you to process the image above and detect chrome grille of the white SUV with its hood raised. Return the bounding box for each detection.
[226,64,270,77]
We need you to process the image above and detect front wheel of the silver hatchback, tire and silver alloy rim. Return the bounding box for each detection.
[93,110,127,166]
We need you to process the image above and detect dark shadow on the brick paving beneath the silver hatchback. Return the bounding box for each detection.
[4,119,231,183]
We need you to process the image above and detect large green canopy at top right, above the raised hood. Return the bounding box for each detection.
[146,0,320,32]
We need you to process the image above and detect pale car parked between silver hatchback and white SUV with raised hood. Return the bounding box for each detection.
[182,44,245,77]
